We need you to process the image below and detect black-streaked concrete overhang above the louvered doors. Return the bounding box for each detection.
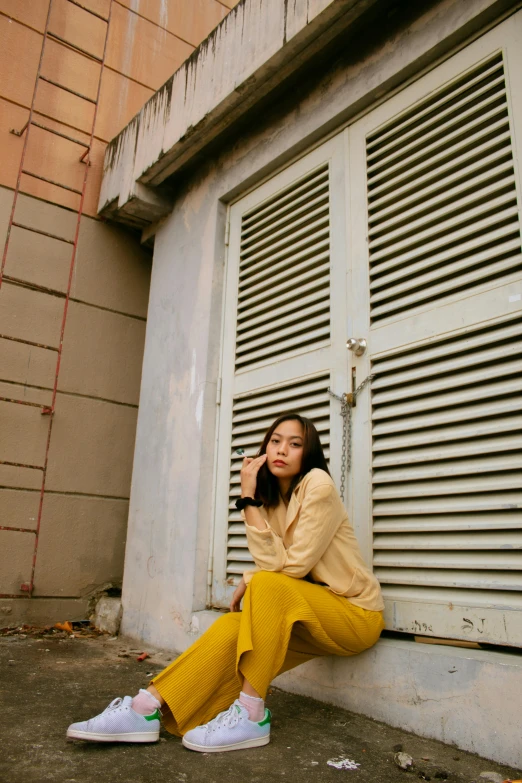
[98,0,383,228]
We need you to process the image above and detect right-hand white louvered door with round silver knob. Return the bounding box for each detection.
[349,13,522,646]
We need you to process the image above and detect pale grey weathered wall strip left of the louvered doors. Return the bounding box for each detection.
[120,182,224,649]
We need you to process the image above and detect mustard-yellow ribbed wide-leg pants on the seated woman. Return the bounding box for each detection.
[152,571,384,735]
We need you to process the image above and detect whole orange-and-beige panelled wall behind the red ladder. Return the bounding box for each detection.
[0,0,240,624]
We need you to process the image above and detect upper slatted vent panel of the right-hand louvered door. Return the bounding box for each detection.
[367,54,522,322]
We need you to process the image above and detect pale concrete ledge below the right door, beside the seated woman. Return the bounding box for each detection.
[275,639,522,768]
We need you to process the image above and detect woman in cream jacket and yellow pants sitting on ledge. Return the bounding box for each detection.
[67,413,384,753]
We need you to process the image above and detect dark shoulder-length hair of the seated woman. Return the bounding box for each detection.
[256,411,330,508]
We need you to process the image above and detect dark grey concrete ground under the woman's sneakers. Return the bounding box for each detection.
[0,629,522,783]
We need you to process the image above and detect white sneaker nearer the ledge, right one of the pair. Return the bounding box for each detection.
[182,700,272,753]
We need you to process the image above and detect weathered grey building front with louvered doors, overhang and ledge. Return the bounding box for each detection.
[100,0,522,766]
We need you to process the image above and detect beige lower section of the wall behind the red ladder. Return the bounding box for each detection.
[0,188,150,622]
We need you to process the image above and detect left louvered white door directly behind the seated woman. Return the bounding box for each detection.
[209,137,346,606]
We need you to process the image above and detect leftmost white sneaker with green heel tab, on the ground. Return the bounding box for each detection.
[67,696,160,742]
